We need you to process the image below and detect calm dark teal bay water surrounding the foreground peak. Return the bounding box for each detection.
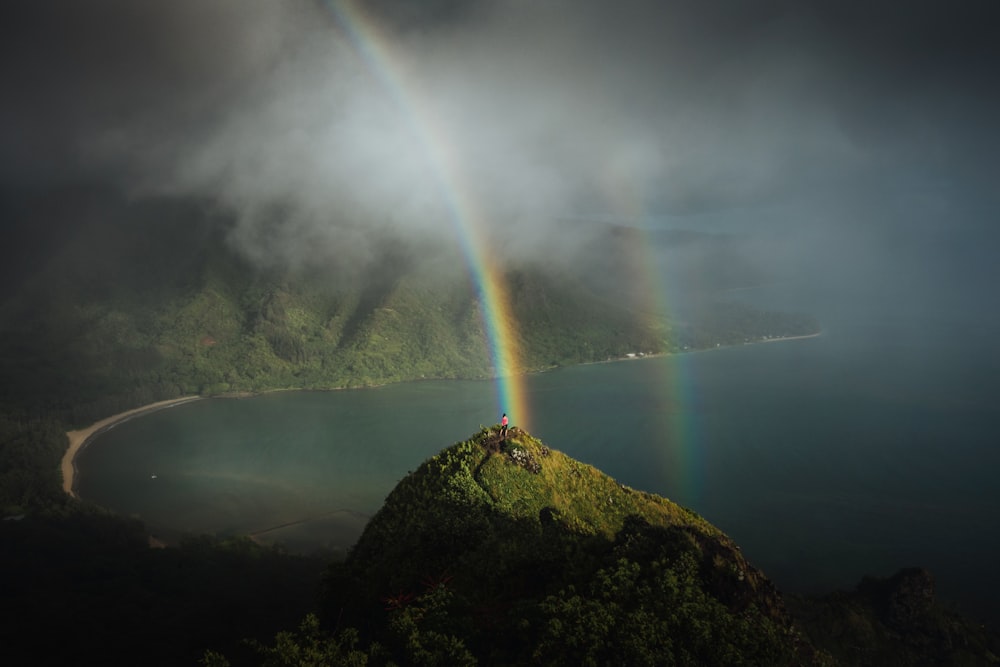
[78,282,1000,622]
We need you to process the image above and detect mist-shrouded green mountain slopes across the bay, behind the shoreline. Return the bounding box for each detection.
[0,191,818,426]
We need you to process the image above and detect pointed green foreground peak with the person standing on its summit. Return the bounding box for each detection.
[325,429,821,665]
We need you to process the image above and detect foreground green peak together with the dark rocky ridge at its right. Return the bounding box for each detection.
[230,426,1000,667]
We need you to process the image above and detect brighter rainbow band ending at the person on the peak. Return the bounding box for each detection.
[323,0,530,428]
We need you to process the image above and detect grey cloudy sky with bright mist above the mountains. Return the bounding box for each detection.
[0,0,1000,276]
